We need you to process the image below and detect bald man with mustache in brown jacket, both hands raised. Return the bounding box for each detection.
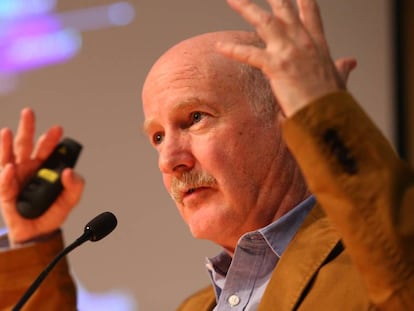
[0,0,414,310]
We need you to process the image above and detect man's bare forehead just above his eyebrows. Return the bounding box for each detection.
[142,53,240,118]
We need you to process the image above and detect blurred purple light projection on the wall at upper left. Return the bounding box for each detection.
[0,0,135,94]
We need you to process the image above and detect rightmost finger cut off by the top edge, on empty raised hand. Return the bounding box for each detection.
[297,0,328,52]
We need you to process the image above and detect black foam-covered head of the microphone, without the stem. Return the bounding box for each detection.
[85,212,118,242]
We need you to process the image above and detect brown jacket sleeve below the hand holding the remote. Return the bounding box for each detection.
[0,232,76,311]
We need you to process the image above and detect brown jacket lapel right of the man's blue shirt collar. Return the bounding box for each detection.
[258,205,340,311]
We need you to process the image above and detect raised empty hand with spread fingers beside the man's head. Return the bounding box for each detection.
[217,0,356,116]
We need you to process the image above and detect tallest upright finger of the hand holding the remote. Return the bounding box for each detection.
[14,108,35,163]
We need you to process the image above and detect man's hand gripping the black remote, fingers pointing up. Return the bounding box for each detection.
[0,108,85,244]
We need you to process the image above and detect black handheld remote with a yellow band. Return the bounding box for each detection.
[17,138,82,219]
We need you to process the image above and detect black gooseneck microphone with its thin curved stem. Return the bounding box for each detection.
[12,212,118,311]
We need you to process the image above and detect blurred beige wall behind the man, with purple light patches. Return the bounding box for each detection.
[0,0,396,311]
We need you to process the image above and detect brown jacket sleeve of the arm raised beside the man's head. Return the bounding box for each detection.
[284,91,414,311]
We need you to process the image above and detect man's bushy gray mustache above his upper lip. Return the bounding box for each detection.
[170,171,217,203]
